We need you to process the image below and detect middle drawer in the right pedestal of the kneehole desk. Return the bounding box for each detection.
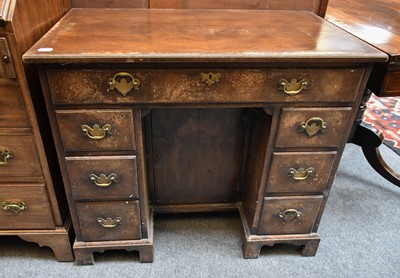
[266,152,336,193]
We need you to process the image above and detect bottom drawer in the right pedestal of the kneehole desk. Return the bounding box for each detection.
[258,196,323,235]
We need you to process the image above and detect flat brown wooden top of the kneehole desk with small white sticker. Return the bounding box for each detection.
[24,9,387,64]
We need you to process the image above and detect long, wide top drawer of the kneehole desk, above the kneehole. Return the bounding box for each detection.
[47,68,364,104]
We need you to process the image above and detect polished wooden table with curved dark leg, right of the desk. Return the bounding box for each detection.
[326,0,400,186]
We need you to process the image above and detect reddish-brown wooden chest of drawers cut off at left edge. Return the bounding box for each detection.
[0,1,73,261]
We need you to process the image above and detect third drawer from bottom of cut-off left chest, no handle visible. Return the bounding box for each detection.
[0,86,29,127]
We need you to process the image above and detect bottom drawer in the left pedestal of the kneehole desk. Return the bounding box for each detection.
[76,201,141,241]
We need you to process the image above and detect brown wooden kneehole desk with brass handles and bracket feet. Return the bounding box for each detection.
[24,9,386,264]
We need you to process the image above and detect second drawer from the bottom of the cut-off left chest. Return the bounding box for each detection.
[0,134,42,177]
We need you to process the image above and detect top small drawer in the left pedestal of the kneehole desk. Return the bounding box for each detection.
[56,110,135,152]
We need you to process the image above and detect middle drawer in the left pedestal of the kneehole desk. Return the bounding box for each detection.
[66,156,139,200]
